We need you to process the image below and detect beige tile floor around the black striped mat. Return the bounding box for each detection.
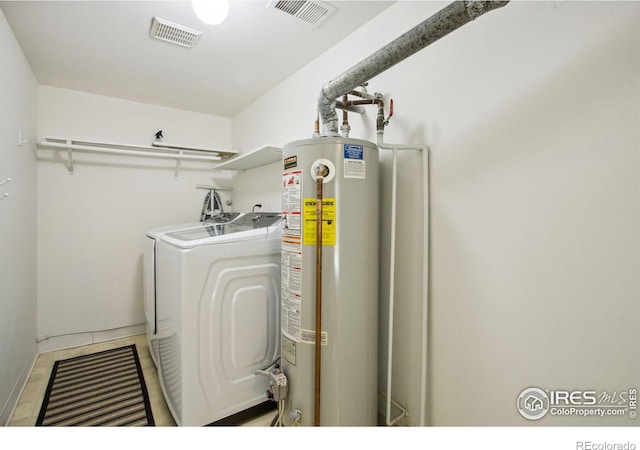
[9,334,275,427]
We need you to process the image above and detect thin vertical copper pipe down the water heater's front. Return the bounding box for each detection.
[313,175,324,427]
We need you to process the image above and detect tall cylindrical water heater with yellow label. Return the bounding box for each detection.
[281,137,379,426]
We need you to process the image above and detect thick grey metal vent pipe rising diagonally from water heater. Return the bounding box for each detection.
[318,0,509,136]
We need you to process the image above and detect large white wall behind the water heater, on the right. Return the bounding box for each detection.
[233,2,640,426]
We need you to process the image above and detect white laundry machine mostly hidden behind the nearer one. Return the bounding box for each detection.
[142,212,242,367]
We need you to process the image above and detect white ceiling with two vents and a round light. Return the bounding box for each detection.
[0,0,395,117]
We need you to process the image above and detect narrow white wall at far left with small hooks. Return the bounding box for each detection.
[0,11,38,426]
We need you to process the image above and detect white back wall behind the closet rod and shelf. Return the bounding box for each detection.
[38,86,231,352]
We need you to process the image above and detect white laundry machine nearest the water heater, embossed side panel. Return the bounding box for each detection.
[156,213,281,426]
